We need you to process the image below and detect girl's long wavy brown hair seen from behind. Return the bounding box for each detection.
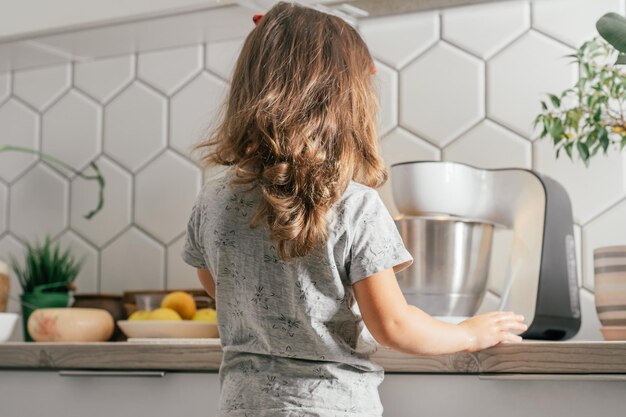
[197,2,387,259]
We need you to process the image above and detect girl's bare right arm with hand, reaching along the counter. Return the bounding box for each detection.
[353,269,526,355]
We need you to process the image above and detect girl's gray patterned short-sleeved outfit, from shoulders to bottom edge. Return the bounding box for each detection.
[182,172,412,417]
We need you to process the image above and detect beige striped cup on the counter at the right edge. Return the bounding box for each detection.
[593,246,626,326]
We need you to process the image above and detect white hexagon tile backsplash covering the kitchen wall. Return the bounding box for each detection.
[0,0,626,342]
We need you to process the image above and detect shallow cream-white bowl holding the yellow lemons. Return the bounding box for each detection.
[117,320,219,339]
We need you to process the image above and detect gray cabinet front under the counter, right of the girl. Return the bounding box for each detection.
[380,374,626,417]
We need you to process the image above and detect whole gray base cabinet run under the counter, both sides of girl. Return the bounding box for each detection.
[0,370,626,417]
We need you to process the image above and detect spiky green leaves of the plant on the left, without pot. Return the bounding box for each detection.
[10,237,84,293]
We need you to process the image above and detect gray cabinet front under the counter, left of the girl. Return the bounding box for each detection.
[0,370,219,417]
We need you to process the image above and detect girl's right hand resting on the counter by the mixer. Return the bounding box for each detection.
[458,311,528,352]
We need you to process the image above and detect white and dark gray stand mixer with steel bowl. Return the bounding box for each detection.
[391,161,581,340]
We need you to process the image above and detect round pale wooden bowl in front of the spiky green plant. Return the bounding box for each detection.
[28,308,114,342]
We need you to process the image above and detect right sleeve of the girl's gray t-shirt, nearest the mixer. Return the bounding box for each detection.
[347,190,413,284]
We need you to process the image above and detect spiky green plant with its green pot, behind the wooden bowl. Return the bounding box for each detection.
[10,237,83,341]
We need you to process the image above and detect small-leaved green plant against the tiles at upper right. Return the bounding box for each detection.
[535,38,626,165]
